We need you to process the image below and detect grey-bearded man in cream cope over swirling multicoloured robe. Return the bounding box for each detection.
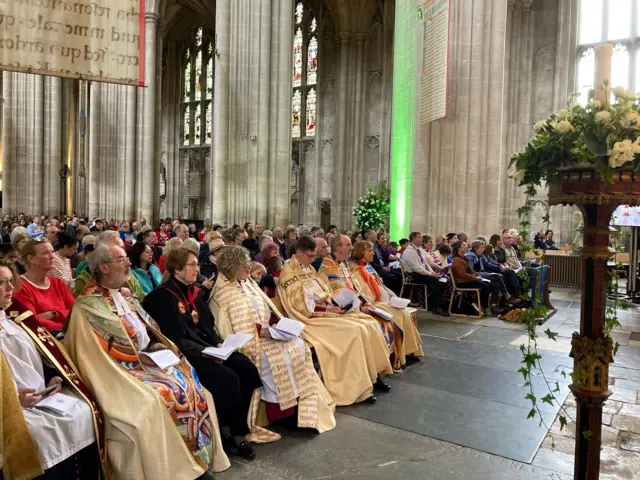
[65,245,229,480]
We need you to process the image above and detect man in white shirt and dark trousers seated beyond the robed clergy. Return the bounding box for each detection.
[401,232,455,317]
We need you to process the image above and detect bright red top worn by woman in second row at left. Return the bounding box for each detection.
[15,277,75,332]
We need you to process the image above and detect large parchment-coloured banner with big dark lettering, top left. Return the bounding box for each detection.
[0,0,144,86]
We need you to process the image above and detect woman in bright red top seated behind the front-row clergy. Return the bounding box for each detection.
[15,238,75,332]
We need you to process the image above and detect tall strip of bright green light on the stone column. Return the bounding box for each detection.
[389,0,416,241]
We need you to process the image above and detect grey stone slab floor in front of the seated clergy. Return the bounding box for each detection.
[216,289,640,480]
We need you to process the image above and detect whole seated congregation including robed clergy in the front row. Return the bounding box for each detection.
[0,214,549,479]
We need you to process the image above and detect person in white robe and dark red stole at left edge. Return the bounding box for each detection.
[0,260,107,480]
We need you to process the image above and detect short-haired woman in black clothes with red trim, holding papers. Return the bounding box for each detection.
[144,247,280,460]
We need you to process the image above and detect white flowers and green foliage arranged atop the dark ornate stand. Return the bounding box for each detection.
[511,84,640,196]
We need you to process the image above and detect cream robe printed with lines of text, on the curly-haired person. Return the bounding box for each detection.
[209,274,336,433]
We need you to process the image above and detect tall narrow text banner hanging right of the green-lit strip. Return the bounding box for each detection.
[418,0,449,125]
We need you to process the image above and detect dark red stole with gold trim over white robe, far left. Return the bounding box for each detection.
[5,300,111,479]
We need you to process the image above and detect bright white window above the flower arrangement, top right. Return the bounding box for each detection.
[577,0,640,104]
